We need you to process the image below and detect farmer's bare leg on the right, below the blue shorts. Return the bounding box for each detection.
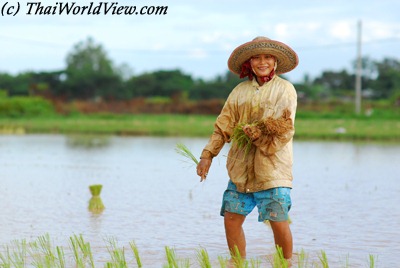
[270,221,293,260]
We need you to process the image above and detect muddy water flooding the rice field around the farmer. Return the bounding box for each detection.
[0,135,400,267]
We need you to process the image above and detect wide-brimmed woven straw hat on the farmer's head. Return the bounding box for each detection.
[228,36,299,74]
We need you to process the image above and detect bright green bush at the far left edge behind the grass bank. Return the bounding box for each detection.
[0,97,55,117]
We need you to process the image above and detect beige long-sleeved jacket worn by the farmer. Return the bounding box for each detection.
[201,75,297,193]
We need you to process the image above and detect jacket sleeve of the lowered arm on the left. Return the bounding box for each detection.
[200,92,237,159]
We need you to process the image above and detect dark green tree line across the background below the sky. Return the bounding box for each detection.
[0,38,400,101]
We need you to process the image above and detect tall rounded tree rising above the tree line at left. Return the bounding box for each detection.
[63,37,122,99]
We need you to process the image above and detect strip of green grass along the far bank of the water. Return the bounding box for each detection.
[0,113,400,141]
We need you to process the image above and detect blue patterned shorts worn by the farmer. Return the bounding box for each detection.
[221,181,292,222]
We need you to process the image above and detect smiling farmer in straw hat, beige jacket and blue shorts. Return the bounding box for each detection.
[197,37,298,260]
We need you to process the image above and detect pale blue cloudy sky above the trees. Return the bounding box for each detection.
[0,0,400,82]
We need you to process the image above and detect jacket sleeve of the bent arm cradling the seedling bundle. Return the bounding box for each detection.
[253,86,297,155]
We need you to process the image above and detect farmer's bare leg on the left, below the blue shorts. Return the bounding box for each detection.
[224,212,246,258]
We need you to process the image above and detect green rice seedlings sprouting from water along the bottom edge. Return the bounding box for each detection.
[0,234,377,268]
